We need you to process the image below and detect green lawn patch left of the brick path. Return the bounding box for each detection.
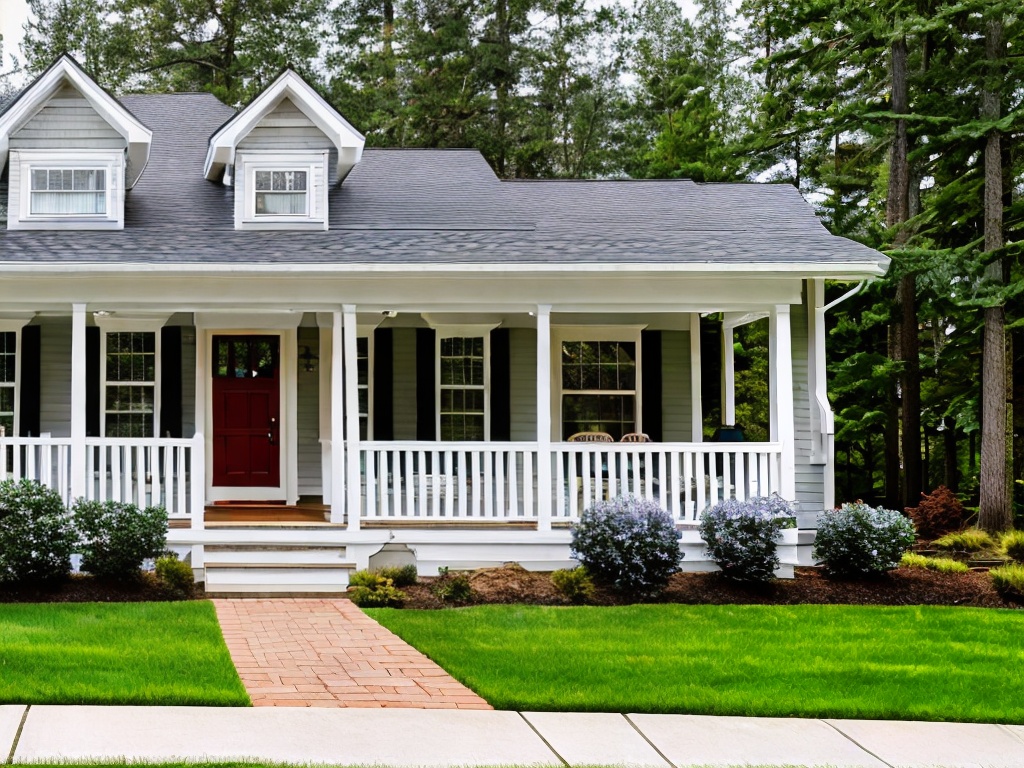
[0,602,250,707]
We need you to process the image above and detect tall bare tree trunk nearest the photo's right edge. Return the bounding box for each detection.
[978,18,1013,532]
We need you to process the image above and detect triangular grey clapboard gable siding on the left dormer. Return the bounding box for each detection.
[10,83,127,150]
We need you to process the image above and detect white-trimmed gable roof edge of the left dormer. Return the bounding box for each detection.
[0,53,153,188]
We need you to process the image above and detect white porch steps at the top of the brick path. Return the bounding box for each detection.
[203,545,355,597]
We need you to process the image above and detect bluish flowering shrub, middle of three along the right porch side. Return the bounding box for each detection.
[697,496,795,582]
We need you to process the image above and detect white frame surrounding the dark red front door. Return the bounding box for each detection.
[196,311,302,505]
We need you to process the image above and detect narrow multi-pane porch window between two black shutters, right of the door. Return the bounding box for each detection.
[437,336,490,440]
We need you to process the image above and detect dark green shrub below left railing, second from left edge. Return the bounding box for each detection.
[73,499,167,580]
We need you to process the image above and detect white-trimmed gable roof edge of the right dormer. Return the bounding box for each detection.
[203,70,366,181]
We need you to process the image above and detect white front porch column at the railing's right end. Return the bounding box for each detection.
[768,304,797,502]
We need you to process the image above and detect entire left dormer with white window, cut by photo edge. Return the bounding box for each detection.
[0,55,153,229]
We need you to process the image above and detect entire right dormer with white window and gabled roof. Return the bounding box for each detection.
[205,70,366,229]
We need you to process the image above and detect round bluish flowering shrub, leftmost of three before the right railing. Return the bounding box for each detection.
[571,496,683,597]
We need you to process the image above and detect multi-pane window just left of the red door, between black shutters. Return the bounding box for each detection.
[103,331,158,437]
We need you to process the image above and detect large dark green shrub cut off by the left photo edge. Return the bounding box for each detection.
[0,480,78,584]
